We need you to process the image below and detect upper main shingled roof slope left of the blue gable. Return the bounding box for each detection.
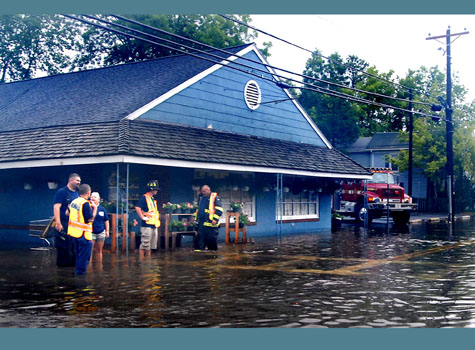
[0,44,250,132]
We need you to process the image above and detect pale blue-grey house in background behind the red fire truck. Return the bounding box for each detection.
[346,132,427,200]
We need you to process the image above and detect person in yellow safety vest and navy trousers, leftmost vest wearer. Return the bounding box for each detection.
[68,184,97,275]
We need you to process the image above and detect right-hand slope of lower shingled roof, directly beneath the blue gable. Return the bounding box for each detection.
[129,120,370,175]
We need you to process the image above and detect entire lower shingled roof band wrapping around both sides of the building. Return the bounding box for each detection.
[0,119,369,175]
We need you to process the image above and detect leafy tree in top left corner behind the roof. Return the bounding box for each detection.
[0,15,75,83]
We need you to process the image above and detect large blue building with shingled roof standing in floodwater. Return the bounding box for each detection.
[0,44,370,242]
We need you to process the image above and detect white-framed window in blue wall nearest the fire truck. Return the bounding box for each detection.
[276,191,319,220]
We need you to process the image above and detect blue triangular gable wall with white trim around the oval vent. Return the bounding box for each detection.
[135,46,331,148]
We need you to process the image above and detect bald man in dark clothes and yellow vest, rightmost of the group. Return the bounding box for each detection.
[195,185,223,251]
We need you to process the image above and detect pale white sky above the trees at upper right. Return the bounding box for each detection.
[250,14,475,103]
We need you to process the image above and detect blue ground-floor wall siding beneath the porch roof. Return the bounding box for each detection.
[0,164,331,246]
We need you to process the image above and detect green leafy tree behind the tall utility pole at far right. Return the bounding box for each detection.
[392,67,475,208]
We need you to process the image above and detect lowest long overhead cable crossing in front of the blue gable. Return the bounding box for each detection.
[62,14,454,125]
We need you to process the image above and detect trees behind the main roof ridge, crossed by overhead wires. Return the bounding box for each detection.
[70,15,258,69]
